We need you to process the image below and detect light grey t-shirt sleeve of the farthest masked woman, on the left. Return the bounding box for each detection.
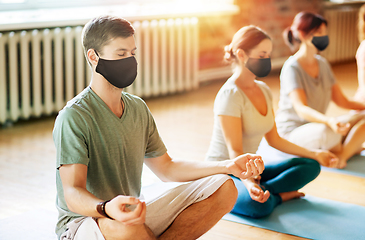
[280,64,304,95]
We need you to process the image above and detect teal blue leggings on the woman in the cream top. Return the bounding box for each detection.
[231,158,321,218]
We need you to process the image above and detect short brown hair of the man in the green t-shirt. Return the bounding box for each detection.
[81,15,134,64]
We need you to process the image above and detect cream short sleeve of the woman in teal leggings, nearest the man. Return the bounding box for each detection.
[214,89,243,117]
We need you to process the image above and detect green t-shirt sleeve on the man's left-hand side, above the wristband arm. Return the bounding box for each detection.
[53,108,89,169]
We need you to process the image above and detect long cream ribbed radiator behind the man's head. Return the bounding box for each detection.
[0,18,198,124]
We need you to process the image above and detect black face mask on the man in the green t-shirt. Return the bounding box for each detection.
[95,51,137,88]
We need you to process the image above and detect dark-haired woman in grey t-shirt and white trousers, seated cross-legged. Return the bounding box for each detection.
[276,12,365,168]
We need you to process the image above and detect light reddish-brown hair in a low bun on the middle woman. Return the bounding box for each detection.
[224,25,271,63]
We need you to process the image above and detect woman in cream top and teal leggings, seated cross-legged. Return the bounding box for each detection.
[206,26,338,218]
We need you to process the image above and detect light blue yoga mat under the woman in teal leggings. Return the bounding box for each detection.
[223,195,365,240]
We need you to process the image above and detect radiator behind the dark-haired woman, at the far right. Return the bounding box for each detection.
[323,8,359,63]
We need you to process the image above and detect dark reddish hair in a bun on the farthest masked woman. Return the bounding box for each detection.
[283,12,327,51]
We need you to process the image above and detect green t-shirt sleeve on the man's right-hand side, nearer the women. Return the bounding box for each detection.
[145,106,167,158]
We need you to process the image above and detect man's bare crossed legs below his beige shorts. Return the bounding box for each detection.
[98,179,237,240]
